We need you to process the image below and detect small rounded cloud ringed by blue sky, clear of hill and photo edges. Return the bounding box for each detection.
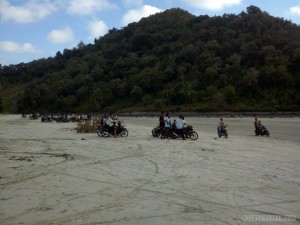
[47,27,74,44]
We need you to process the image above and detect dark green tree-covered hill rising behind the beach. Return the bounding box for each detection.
[0,6,300,112]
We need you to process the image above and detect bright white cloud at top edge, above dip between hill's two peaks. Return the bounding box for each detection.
[182,0,242,11]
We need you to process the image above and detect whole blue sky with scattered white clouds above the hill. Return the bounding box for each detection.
[0,0,300,65]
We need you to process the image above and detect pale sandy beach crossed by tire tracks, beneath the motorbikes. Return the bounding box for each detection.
[0,115,300,225]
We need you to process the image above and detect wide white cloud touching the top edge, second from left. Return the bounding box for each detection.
[67,0,117,16]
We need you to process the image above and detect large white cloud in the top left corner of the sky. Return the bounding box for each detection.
[0,0,56,23]
